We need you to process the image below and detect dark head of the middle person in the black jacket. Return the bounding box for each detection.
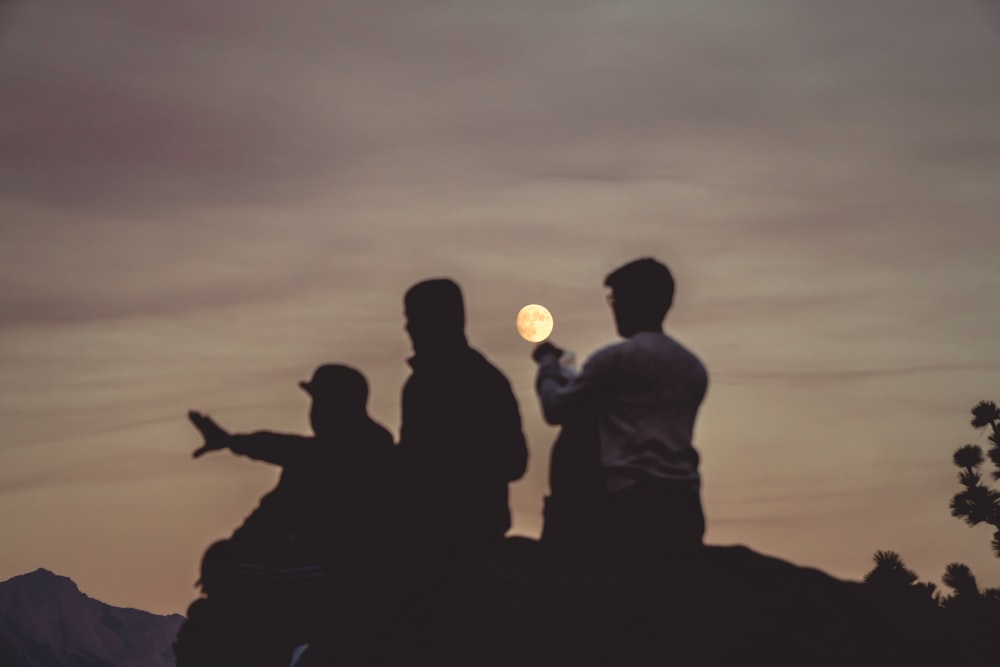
[403,278,465,354]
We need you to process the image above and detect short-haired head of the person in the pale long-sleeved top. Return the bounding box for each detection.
[604,257,674,338]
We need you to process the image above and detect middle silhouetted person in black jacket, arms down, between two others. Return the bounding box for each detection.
[398,278,528,547]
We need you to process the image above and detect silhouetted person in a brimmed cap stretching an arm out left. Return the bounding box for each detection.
[178,364,399,664]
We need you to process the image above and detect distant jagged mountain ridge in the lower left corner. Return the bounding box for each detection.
[0,568,184,667]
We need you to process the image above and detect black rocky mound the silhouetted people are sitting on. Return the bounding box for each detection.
[292,538,988,667]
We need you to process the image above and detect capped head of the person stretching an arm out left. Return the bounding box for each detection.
[299,364,368,435]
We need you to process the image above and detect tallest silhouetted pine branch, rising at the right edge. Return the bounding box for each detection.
[949,401,1000,569]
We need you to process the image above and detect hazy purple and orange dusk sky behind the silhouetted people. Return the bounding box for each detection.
[0,0,1000,613]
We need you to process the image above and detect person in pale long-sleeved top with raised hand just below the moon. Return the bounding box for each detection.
[532,258,708,551]
